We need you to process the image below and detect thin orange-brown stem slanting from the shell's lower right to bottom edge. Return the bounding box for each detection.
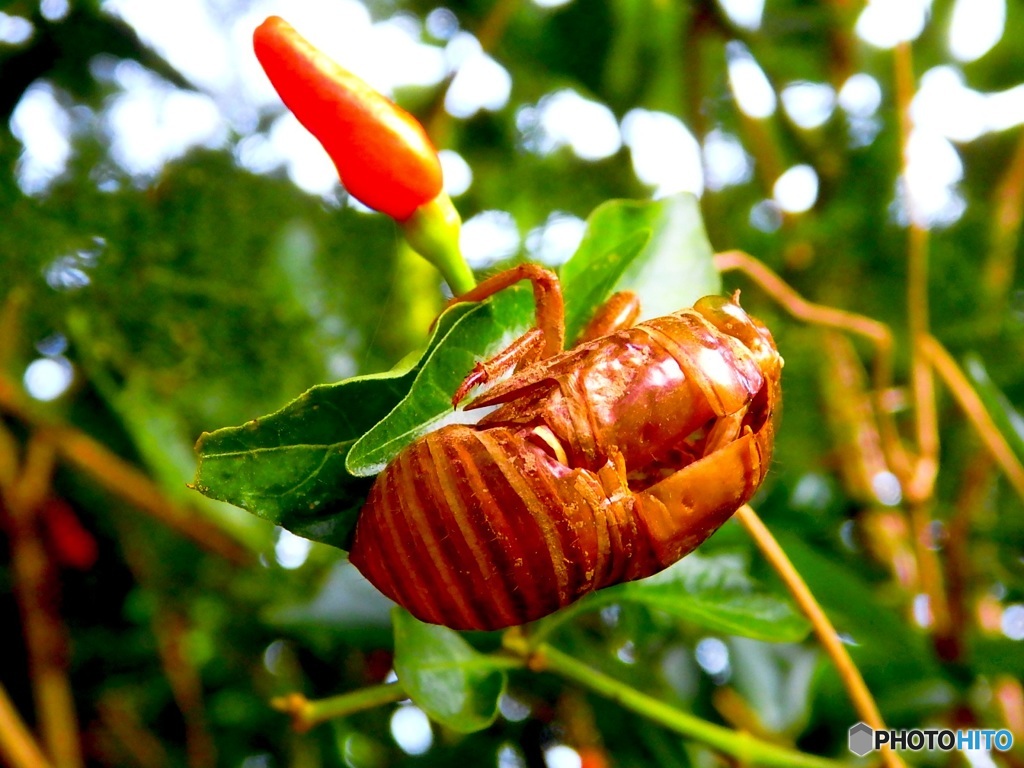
[736,504,904,768]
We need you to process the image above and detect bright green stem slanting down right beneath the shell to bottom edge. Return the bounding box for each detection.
[510,643,842,768]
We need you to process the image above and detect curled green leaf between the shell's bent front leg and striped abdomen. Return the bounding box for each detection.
[347,285,535,476]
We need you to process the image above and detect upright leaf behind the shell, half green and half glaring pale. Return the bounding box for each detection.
[561,194,722,339]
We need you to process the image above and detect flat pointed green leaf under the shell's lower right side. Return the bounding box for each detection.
[598,553,810,643]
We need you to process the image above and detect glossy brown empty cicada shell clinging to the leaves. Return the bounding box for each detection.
[350,265,782,630]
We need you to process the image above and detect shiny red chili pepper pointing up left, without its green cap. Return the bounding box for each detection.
[253,16,441,221]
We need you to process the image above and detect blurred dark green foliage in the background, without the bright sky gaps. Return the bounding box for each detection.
[0,0,1024,768]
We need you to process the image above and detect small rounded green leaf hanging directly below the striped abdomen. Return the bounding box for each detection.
[392,608,507,733]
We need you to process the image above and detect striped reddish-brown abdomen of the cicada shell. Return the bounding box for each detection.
[350,425,650,630]
